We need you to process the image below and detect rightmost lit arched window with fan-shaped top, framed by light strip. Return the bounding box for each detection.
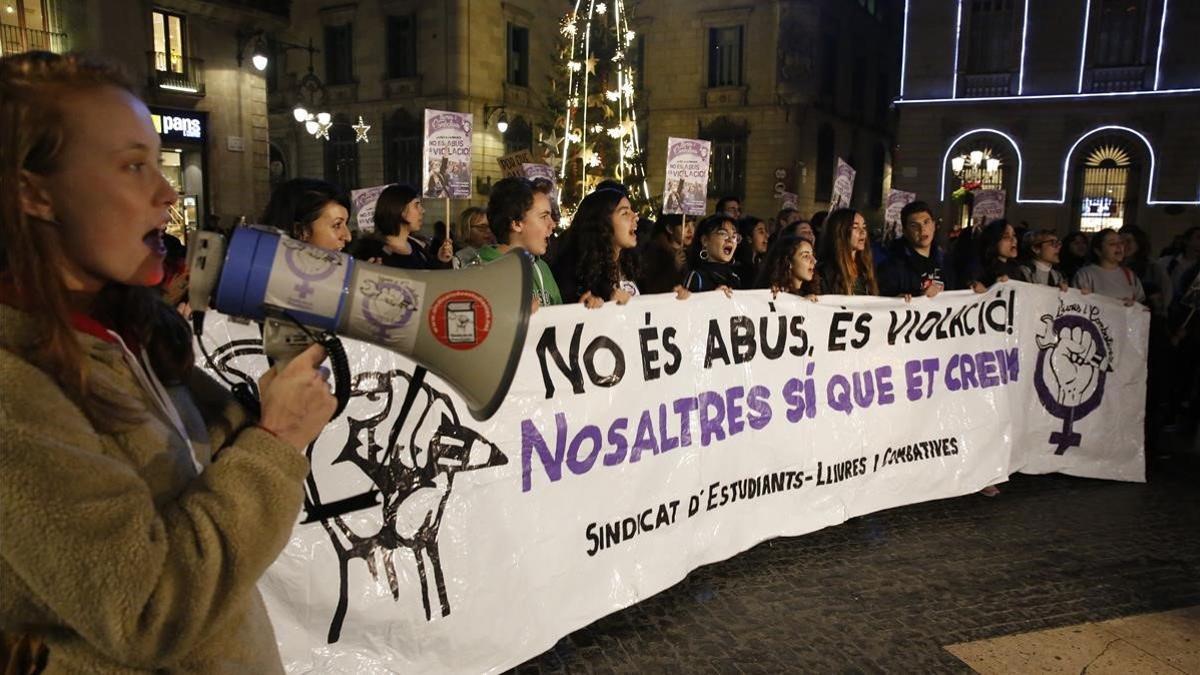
[1075,138,1140,232]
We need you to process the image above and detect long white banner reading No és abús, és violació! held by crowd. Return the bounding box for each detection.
[194,282,1148,673]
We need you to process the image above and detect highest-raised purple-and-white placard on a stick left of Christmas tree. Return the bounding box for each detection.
[421,108,472,199]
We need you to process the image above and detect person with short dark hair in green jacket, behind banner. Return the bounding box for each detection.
[479,177,563,305]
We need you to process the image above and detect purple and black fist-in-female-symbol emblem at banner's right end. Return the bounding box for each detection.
[1033,309,1112,455]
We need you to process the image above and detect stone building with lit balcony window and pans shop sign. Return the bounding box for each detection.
[46,0,288,234]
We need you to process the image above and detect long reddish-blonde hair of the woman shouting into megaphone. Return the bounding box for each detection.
[0,52,171,430]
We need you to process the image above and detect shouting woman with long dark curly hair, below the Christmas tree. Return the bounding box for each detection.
[553,190,640,307]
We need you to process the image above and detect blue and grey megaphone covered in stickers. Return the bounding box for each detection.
[187,226,533,419]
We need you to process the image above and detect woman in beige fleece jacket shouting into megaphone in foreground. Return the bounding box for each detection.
[0,52,336,673]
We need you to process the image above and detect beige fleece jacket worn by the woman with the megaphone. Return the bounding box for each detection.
[0,305,308,674]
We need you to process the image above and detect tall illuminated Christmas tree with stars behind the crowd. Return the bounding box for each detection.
[542,0,649,213]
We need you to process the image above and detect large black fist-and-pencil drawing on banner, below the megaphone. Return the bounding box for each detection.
[206,340,508,644]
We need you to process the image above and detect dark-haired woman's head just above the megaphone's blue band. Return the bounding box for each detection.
[260,178,350,251]
